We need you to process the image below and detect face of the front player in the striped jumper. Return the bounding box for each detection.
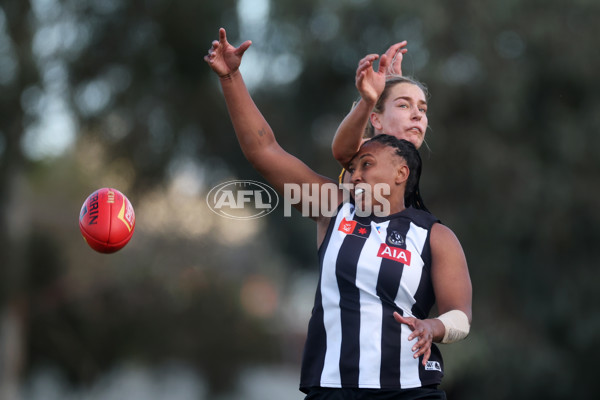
[348,142,409,213]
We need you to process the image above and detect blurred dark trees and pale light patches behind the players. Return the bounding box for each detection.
[0,0,600,400]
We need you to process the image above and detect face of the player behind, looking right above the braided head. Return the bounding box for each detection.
[371,82,428,149]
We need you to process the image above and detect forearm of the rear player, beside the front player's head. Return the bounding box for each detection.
[331,98,373,167]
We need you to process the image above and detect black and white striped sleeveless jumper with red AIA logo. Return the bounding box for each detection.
[300,203,443,392]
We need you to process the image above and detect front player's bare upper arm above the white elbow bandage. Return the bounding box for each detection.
[430,223,473,321]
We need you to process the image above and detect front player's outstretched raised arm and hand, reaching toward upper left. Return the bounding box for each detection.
[204,28,341,222]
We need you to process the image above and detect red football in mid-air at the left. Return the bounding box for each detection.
[79,188,135,253]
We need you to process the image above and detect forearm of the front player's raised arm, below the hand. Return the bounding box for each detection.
[219,70,275,163]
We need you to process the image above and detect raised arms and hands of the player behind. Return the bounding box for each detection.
[331,41,407,168]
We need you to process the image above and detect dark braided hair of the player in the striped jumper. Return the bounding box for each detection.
[364,134,429,212]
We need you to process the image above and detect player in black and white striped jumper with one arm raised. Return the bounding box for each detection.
[205,28,472,400]
